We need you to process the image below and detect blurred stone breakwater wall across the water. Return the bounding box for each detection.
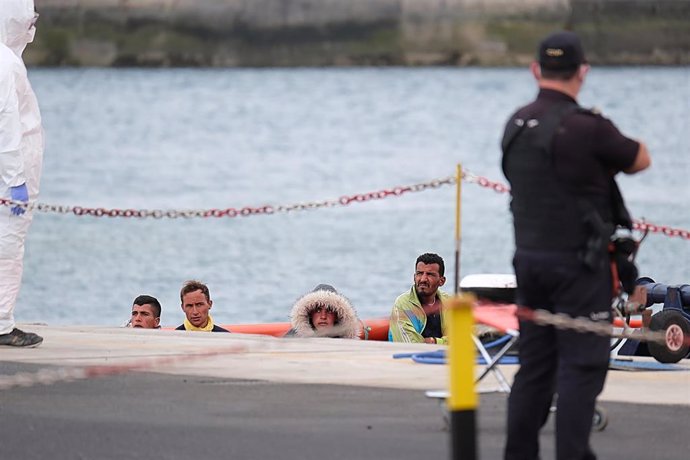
[25,0,690,67]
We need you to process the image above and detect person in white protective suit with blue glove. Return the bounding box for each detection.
[0,0,44,347]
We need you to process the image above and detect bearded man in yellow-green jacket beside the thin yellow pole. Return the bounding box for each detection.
[388,253,449,345]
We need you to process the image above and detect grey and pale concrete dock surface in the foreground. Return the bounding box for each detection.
[0,325,690,460]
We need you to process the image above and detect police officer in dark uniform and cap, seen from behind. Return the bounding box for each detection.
[502,32,650,460]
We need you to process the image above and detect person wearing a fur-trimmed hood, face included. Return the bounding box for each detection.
[285,284,361,339]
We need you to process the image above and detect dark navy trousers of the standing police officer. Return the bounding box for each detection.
[505,249,612,460]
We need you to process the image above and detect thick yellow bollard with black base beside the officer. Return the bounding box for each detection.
[446,294,478,460]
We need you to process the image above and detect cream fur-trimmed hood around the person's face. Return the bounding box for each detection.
[288,285,361,339]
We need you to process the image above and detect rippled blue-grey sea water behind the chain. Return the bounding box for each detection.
[15,67,690,326]
